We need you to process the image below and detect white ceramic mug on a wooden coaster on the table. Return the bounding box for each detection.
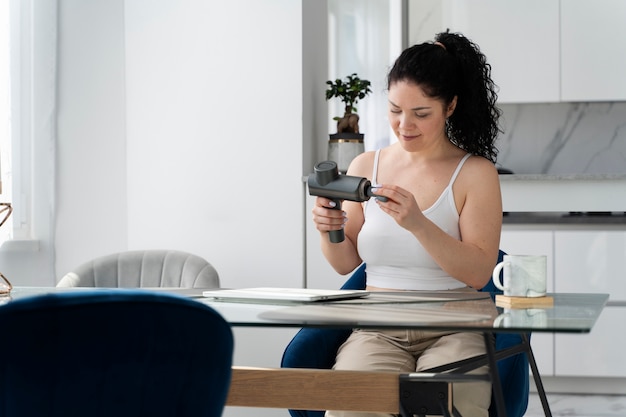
[492,255,547,297]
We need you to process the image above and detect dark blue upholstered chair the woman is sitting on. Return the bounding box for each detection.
[281,251,529,417]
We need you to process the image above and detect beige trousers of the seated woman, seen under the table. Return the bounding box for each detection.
[326,330,491,417]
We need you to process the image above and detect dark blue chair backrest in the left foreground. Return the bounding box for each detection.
[0,289,233,417]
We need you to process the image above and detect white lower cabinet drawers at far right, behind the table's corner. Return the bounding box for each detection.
[554,230,626,377]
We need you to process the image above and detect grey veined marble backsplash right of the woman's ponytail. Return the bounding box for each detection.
[496,102,626,174]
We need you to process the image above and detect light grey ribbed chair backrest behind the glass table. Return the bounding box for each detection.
[57,250,220,288]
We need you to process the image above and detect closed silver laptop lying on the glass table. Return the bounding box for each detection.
[202,287,369,303]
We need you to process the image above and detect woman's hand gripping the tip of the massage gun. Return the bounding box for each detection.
[372,185,424,231]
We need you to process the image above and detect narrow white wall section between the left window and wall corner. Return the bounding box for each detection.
[54,0,132,279]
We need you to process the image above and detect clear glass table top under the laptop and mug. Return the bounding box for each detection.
[0,287,609,333]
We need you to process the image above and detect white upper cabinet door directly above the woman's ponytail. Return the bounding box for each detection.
[443,0,560,103]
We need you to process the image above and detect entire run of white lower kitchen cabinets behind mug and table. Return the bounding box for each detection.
[500,225,626,378]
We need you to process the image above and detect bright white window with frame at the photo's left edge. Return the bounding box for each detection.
[0,0,43,245]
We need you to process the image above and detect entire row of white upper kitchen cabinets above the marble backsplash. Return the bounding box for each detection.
[408,0,626,103]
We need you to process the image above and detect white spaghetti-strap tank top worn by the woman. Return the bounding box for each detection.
[358,149,471,291]
